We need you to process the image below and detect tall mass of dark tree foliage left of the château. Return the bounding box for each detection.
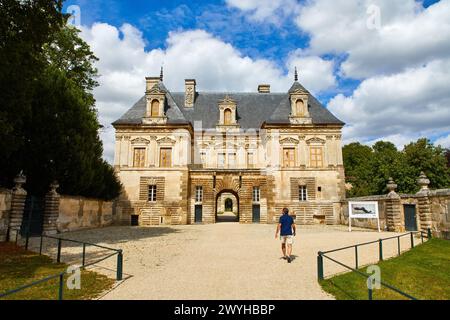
[0,0,121,200]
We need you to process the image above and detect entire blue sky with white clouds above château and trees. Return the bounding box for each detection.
[65,0,450,162]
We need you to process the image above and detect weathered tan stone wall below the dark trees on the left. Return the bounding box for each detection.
[57,196,115,233]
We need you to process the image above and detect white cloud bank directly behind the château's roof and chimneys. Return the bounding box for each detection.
[82,23,336,162]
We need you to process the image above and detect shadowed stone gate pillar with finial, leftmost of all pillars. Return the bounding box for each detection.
[9,172,27,241]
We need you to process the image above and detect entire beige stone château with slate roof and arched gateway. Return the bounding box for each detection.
[113,76,345,225]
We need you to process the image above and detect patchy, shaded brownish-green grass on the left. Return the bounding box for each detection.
[0,243,115,300]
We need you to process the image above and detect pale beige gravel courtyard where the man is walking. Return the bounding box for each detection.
[27,223,419,300]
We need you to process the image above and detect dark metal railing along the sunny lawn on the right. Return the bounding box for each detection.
[317,229,432,300]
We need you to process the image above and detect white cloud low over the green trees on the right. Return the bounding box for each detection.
[328,59,450,144]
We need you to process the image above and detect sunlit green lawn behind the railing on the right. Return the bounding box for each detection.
[320,239,450,300]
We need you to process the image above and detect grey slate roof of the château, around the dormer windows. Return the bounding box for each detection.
[113,82,344,129]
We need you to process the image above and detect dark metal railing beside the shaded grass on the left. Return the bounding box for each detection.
[0,232,123,300]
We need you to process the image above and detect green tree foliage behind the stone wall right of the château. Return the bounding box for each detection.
[343,139,450,197]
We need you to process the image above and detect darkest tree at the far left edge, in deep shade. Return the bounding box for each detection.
[0,0,65,186]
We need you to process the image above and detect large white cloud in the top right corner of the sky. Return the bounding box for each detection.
[297,0,450,78]
